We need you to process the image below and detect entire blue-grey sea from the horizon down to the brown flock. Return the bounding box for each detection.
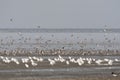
[0,28,120,50]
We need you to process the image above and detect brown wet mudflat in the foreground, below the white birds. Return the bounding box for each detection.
[0,56,120,80]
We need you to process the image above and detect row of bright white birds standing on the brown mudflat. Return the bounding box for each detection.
[0,55,120,68]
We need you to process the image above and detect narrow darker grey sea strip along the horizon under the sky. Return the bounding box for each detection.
[0,28,120,33]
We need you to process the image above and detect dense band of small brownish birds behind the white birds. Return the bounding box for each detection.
[0,48,120,56]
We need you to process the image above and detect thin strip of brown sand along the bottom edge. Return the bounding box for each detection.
[0,76,120,80]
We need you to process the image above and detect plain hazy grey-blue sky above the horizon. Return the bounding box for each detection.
[0,0,120,28]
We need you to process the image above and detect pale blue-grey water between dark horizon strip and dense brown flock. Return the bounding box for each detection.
[0,33,120,50]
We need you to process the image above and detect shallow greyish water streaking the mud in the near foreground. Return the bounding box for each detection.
[0,67,120,78]
